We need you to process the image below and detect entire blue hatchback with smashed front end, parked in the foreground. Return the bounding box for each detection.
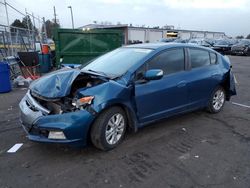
[19,43,236,150]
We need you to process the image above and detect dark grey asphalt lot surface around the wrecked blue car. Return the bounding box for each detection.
[0,56,250,188]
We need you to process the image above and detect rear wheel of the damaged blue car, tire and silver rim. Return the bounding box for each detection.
[207,86,226,114]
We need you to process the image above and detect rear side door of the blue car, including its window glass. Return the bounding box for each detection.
[188,48,222,108]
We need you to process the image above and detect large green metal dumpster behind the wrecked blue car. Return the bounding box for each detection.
[54,29,123,67]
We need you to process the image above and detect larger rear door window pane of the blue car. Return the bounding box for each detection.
[189,49,210,68]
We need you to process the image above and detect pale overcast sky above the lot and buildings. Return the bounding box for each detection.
[0,0,250,36]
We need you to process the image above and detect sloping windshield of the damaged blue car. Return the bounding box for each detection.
[82,48,152,77]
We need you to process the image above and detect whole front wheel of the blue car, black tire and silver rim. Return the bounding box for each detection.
[90,107,127,151]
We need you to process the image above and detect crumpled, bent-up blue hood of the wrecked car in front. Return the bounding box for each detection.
[30,68,81,98]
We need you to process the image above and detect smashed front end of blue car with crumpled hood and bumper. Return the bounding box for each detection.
[19,69,105,145]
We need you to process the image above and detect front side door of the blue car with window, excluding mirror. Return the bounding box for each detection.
[135,48,188,122]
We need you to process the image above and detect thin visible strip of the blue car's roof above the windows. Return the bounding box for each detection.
[124,42,211,50]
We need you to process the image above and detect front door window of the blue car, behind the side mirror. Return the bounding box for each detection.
[147,48,184,75]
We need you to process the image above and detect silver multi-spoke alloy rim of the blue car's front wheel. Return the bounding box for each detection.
[105,113,125,145]
